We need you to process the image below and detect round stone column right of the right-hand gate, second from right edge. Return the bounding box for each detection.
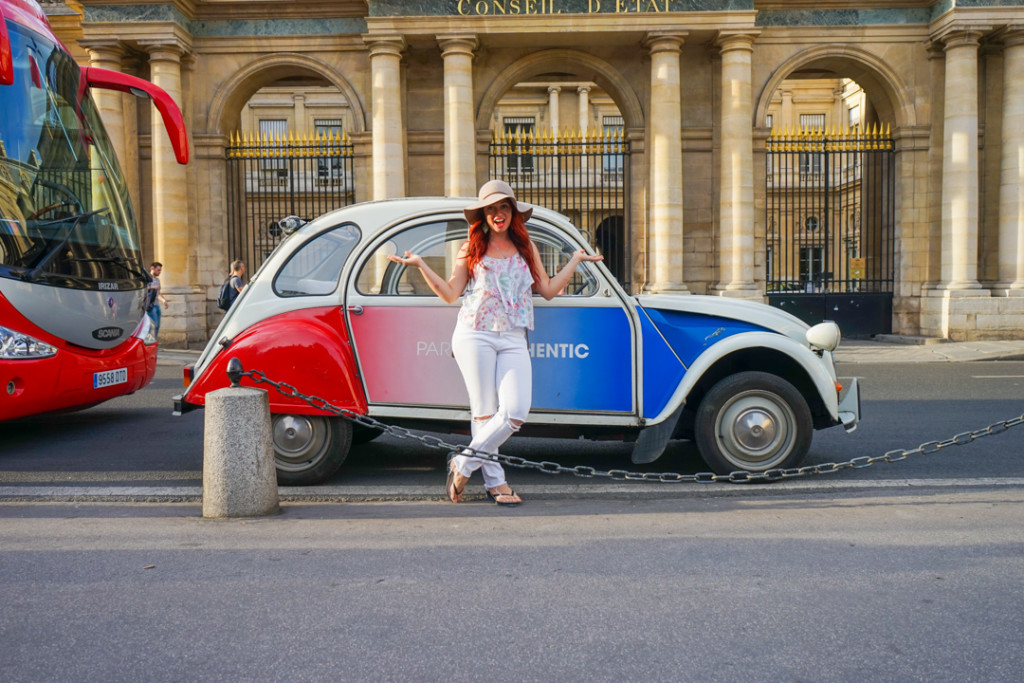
[940,30,981,291]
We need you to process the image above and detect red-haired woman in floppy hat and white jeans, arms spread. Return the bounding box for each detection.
[388,180,603,505]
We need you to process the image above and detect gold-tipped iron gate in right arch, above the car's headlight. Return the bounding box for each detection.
[765,126,896,336]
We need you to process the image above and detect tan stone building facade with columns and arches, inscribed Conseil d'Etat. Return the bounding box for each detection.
[42,0,1024,346]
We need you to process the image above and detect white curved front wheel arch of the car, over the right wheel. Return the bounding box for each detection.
[647,332,840,425]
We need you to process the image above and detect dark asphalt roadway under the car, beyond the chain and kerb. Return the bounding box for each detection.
[0,361,1024,500]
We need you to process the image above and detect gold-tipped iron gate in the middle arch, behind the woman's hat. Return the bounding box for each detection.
[489,126,632,291]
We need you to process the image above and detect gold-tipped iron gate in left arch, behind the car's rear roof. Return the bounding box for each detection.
[226,133,355,272]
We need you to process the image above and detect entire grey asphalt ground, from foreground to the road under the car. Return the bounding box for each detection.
[0,361,1024,683]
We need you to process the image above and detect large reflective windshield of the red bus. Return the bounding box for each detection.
[0,15,142,290]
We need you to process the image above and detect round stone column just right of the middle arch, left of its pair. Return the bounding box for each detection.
[645,34,688,294]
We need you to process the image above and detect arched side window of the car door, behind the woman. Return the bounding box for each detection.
[355,219,598,296]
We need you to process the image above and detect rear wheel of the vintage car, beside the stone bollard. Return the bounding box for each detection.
[270,415,352,486]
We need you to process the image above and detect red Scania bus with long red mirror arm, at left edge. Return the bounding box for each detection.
[0,0,188,420]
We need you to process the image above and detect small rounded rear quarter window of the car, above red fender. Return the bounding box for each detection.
[273,223,359,297]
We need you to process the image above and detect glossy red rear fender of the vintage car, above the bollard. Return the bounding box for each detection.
[183,307,367,415]
